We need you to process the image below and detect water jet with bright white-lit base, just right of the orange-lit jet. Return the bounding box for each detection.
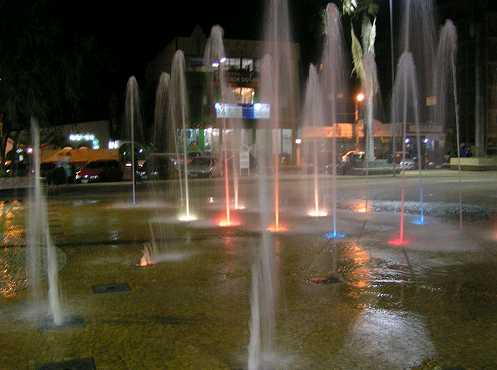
[302,64,327,217]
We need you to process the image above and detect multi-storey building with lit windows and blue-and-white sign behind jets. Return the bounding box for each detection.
[146,26,301,156]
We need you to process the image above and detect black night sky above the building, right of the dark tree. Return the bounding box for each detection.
[63,0,325,76]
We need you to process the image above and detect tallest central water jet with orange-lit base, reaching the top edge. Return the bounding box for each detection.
[261,0,297,231]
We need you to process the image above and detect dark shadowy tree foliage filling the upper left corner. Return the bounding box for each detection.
[0,0,113,129]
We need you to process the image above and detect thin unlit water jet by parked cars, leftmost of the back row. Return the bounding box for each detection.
[124,76,143,205]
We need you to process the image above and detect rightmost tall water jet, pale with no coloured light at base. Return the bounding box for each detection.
[435,20,463,228]
